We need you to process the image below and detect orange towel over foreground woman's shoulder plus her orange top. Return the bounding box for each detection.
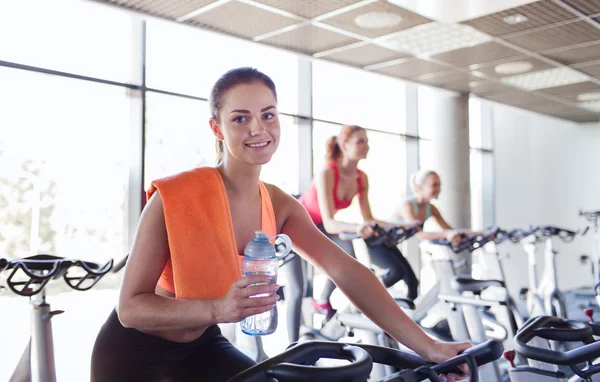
[147,167,277,299]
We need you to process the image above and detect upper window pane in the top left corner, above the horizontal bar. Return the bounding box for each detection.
[0,0,133,83]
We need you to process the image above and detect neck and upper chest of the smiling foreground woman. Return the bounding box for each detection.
[216,156,262,199]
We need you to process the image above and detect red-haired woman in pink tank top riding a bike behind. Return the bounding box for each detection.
[300,126,418,317]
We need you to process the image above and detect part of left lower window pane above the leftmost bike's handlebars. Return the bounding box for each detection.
[0,67,130,261]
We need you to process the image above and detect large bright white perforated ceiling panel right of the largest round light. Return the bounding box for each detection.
[377,21,491,57]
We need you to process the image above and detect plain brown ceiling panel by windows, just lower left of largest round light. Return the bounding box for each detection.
[262,25,358,54]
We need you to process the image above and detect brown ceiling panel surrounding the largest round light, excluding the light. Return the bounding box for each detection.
[320,0,430,37]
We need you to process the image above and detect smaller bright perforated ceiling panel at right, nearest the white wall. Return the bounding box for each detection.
[502,68,588,90]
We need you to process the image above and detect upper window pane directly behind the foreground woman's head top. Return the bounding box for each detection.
[146,20,298,114]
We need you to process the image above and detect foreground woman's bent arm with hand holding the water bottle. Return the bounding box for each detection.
[117,192,275,332]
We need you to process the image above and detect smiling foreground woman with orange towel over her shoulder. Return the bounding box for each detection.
[92,68,469,382]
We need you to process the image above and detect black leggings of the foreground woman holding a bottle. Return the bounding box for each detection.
[91,310,255,382]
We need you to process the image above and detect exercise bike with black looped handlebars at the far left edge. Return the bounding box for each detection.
[0,254,126,382]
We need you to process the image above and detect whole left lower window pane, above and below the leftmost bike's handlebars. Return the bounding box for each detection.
[0,67,130,381]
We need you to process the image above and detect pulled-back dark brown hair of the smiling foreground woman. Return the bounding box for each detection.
[208,67,277,163]
